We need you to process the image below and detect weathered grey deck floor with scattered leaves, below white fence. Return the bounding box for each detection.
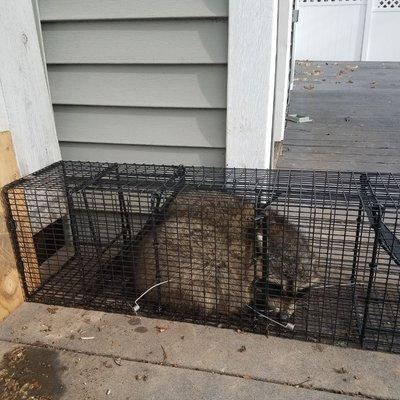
[277,61,400,172]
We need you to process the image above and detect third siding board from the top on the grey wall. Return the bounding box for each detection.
[48,65,227,108]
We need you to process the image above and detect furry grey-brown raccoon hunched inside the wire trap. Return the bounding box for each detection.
[135,189,315,318]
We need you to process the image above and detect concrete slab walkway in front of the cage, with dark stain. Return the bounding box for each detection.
[0,303,400,400]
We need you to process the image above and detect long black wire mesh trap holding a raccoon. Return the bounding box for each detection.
[5,161,400,352]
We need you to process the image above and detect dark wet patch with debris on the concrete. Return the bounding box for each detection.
[0,346,65,400]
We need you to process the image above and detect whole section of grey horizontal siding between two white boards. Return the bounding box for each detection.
[39,0,228,166]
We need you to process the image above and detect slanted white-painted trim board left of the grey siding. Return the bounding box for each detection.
[0,0,61,175]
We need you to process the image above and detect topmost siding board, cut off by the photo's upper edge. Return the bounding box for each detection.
[39,0,228,21]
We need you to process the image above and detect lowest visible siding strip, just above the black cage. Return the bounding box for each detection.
[60,142,225,167]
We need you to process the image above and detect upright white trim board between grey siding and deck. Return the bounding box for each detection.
[226,0,278,168]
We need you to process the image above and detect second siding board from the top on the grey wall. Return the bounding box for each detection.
[42,20,228,64]
